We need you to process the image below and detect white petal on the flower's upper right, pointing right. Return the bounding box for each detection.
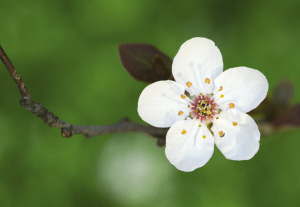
[214,67,269,113]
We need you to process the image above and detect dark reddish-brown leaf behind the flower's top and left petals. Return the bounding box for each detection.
[118,44,172,83]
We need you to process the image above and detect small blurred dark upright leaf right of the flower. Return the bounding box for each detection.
[273,80,294,107]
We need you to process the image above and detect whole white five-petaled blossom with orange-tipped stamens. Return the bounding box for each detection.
[138,37,268,171]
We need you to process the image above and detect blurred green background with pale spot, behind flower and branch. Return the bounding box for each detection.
[0,0,300,207]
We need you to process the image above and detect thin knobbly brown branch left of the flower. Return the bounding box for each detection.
[0,45,168,146]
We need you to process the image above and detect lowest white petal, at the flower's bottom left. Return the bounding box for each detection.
[165,119,214,172]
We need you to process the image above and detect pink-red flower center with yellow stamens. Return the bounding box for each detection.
[191,94,218,122]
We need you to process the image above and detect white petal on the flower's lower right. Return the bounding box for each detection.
[211,109,260,160]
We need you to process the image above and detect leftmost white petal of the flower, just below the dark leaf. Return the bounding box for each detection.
[138,81,189,127]
